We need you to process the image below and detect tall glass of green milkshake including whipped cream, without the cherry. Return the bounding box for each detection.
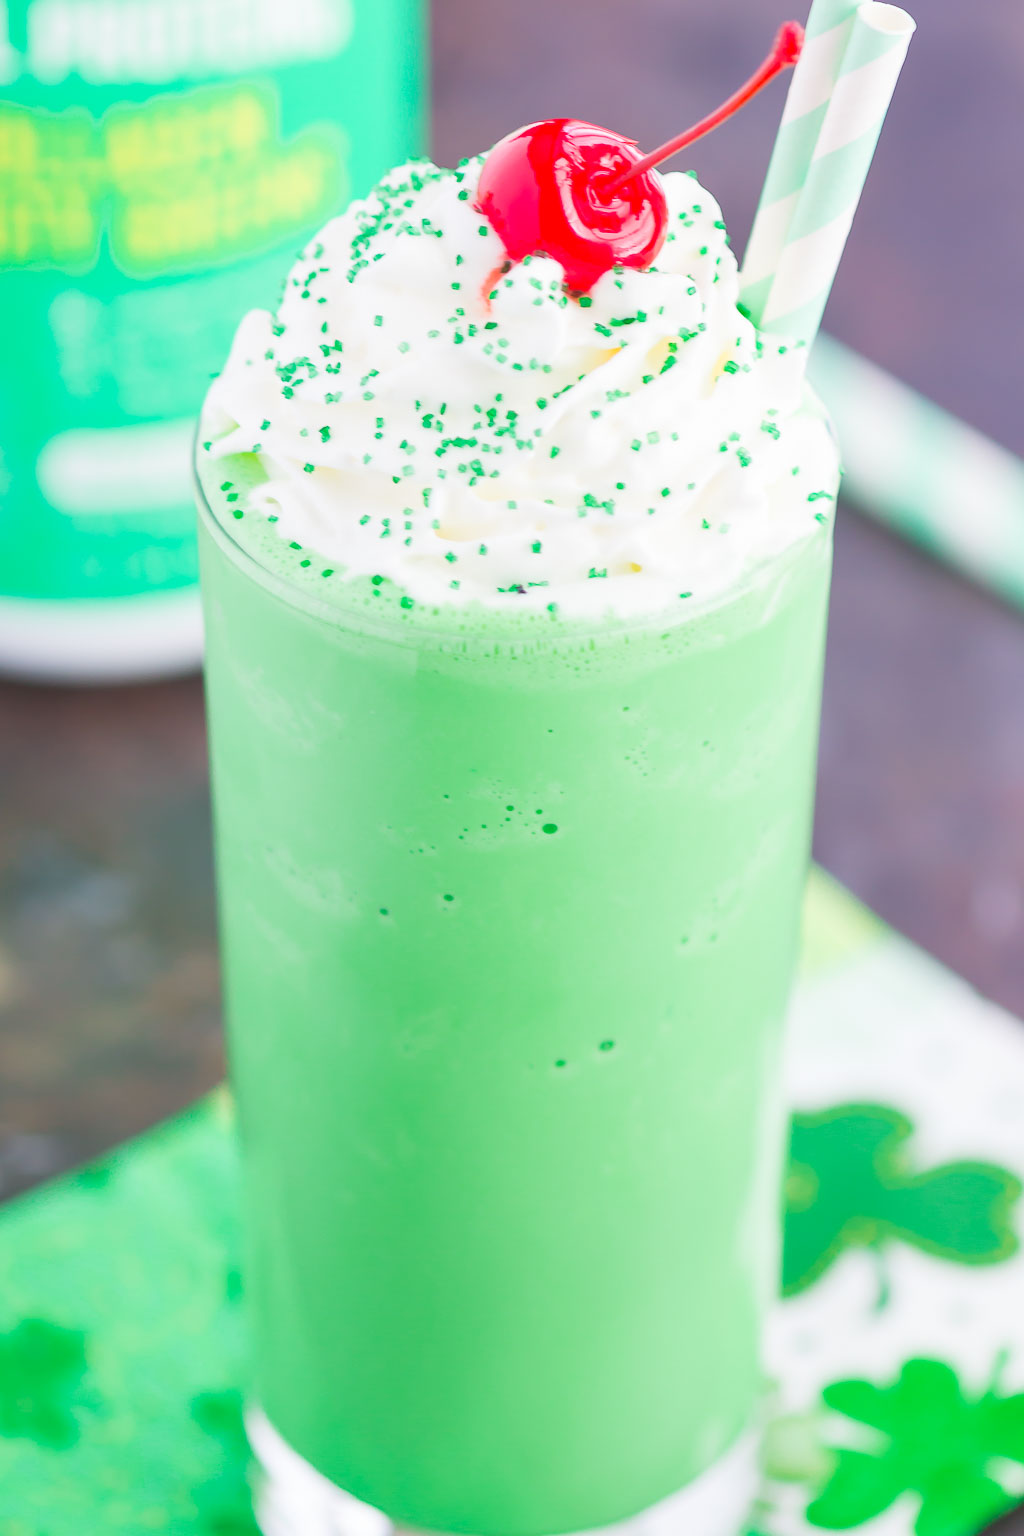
[198,146,837,1536]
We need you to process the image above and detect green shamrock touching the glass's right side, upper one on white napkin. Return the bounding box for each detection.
[783,1104,1021,1296]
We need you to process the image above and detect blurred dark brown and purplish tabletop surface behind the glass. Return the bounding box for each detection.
[0,0,1024,1197]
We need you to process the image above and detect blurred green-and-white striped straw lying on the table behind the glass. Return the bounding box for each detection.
[809,336,1024,607]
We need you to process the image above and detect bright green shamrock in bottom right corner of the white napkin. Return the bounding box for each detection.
[806,1359,1024,1536]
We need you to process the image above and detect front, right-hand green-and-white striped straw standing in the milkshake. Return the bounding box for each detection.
[742,0,915,346]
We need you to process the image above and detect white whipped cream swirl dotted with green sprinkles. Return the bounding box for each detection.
[203,160,837,614]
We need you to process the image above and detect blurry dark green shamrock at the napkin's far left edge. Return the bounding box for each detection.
[0,1318,86,1450]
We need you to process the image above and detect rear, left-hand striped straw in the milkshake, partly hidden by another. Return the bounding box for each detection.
[740,0,861,324]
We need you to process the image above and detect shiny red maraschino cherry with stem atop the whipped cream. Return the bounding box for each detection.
[476,22,803,296]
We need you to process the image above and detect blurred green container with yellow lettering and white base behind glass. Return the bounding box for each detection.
[0,0,424,680]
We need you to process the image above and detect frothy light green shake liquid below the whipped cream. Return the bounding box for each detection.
[201,467,831,1536]
